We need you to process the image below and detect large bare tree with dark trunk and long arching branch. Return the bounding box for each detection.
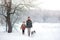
[0,0,34,33]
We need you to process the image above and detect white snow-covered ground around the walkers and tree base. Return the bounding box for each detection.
[0,22,60,40]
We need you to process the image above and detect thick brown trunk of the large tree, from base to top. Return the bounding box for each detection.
[6,0,12,33]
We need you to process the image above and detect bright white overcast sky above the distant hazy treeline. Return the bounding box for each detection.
[38,0,60,10]
